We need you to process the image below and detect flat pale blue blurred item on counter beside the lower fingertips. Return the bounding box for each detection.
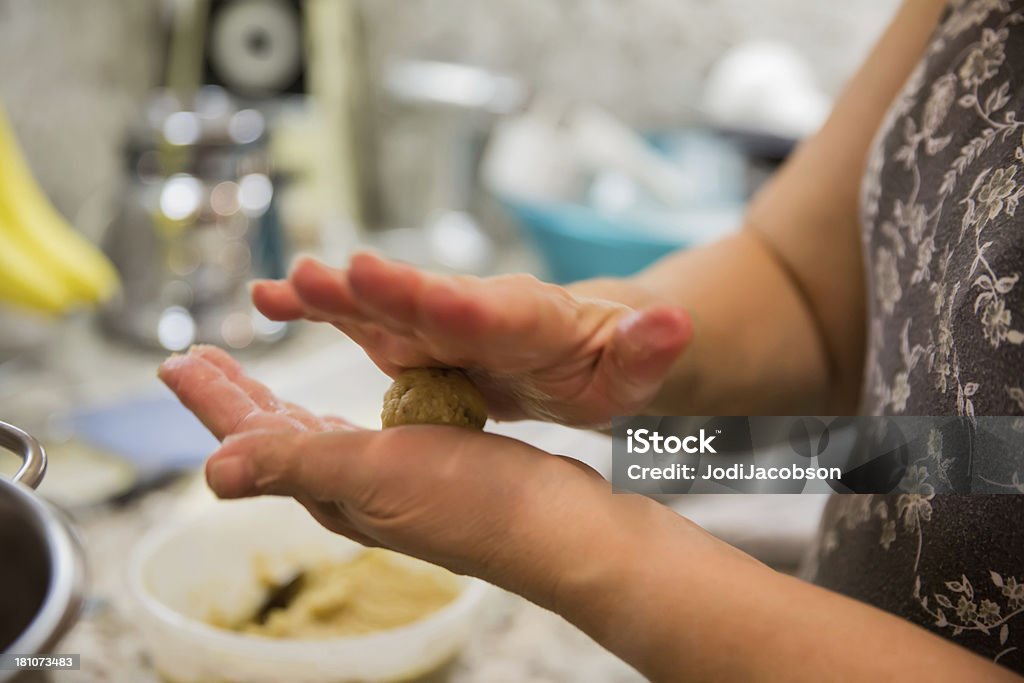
[59,395,217,476]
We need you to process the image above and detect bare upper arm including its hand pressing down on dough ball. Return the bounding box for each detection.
[253,0,942,426]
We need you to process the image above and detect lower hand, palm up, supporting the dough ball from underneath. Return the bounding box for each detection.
[154,347,647,606]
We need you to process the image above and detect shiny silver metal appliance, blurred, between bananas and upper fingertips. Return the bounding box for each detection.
[101,86,286,351]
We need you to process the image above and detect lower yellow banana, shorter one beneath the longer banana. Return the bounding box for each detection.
[0,214,75,314]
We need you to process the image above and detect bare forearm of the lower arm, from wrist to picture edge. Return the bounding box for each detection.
[559,497,1019,683]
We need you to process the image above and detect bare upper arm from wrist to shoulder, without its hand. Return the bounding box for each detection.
[570,0,944,415]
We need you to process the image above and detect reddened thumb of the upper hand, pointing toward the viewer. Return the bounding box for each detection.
[602,306,693,407]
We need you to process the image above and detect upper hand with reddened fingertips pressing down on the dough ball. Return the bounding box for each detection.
[252,254,691,426]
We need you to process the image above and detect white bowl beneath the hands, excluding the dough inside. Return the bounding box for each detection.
[128,498,489,683]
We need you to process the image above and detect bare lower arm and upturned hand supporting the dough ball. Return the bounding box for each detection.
[160,347,1018,683]
